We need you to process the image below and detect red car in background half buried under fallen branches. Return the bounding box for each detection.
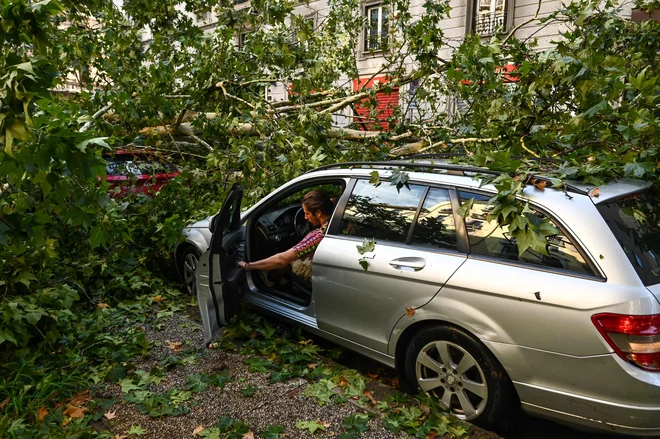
[103,149,181,197]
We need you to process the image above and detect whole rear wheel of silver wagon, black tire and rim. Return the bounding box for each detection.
[405,326,519,429]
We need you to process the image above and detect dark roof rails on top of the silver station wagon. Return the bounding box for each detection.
[307,159,588,195]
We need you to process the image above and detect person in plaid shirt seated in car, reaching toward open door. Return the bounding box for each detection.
[238,190,335,280]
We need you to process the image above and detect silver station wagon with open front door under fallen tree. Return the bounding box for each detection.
[184,161,660,436]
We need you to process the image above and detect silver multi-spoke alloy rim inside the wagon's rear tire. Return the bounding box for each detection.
[415,341,488,421]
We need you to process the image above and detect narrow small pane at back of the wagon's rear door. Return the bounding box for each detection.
[410,188,457,250]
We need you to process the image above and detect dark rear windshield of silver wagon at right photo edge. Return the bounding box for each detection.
[597,190,660,286]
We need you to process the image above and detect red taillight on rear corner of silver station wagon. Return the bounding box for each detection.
[591,313,660,372]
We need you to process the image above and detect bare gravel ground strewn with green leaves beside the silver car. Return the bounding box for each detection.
[96,313,498,439]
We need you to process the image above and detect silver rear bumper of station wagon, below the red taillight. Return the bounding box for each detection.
[484,341,660,436]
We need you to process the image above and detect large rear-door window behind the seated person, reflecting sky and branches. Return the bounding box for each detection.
[341,180,425,243]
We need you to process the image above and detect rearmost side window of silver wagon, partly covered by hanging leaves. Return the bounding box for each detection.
[460,191,594,275]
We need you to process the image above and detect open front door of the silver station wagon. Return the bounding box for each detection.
[195,183,245,346]
